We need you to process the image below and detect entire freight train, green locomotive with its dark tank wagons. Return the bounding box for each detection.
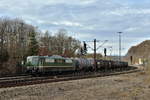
[25,55,128,73]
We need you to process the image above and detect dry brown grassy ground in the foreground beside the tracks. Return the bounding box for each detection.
[0,72,150,100]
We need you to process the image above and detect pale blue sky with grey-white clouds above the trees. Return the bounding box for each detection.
[0,0,150,55]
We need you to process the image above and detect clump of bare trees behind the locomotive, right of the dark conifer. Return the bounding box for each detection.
[40,29,80,57]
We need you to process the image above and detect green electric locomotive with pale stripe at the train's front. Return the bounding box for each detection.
[26,55,75,73]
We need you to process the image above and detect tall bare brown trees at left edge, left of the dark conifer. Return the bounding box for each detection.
[0,18,37,73]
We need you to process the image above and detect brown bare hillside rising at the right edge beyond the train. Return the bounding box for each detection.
[125,40,150,64]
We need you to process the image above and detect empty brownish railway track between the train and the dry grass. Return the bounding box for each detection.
[0,68,141,88]
